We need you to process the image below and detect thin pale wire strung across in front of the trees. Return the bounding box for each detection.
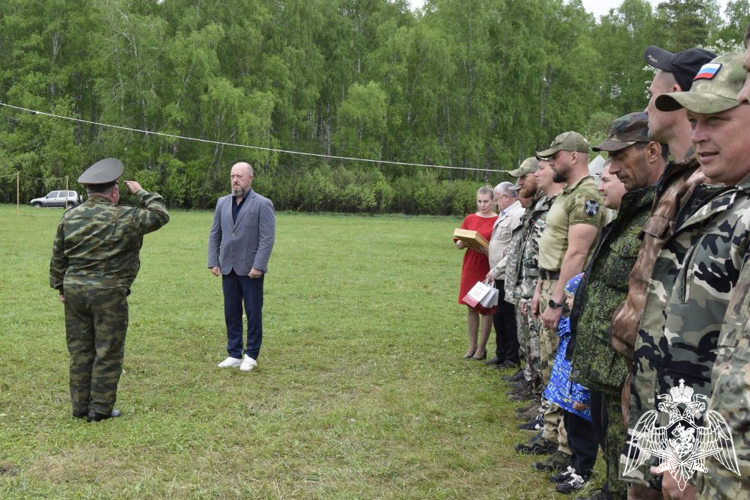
[0,101,507,173]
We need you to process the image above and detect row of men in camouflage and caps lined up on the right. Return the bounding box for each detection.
[494,26,750,498]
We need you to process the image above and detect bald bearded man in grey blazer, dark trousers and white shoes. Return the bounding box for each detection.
[208,162,276,371]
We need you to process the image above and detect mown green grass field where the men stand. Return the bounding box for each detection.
[0,205,601,499]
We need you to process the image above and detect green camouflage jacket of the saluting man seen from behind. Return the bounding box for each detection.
[49,189,169,294]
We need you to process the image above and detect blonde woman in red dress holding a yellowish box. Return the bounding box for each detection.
[454,186,497,361]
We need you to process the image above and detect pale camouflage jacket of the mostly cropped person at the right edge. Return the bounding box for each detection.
[696,243,750,499]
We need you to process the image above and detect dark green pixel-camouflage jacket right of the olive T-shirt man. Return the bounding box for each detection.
[569,187,656,396]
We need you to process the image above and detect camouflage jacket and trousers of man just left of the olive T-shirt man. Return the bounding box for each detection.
[505,193,555,389]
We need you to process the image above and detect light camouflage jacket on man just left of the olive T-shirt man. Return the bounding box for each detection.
[505,193,557,302]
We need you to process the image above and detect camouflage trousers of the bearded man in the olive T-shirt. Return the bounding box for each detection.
[538,280,571,454]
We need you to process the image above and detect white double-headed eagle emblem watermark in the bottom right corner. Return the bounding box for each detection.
[623,379,740,491]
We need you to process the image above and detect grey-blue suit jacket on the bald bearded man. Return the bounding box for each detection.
[208,189,276,276]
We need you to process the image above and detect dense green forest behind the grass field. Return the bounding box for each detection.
[0,0,750,214]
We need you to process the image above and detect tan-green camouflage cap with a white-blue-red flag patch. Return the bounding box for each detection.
[656,54,747,115]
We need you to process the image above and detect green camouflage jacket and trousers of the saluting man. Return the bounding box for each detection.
[50,189,169,414]
